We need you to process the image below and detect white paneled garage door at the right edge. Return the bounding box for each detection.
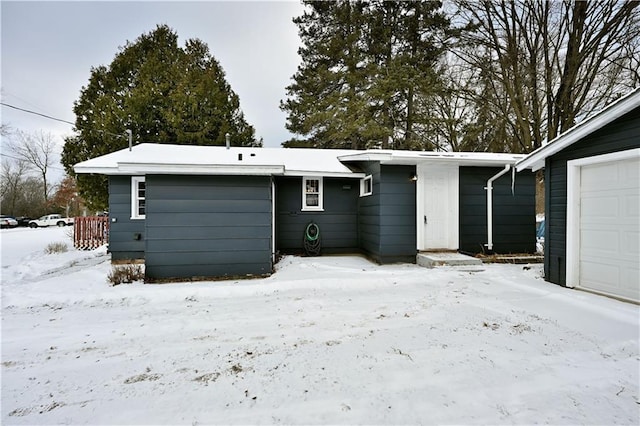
[577,156,640,301]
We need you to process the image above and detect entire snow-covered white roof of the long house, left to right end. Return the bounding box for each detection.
[73,143,524,178]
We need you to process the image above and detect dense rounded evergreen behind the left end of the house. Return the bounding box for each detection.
[62,25,258,209]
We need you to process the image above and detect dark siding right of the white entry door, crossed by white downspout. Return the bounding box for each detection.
[459,167,536,254]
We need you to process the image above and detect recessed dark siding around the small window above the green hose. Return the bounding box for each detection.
[275,177,360,253]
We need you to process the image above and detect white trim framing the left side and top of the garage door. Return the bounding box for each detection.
[565,148,640,287]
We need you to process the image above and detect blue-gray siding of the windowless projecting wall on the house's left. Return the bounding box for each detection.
[145,175,272,280]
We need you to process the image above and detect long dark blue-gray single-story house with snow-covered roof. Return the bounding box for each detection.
[74,144,535,280]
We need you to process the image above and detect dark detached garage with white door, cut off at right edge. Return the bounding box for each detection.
[516,90,640,303]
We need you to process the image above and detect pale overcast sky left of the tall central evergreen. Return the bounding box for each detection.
[0,0,303,156]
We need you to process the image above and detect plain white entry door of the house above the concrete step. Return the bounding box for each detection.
[416,163,459,250]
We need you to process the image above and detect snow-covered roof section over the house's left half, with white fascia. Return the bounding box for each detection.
[73,143,364,178]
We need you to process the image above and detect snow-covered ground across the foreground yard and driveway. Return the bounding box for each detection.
[0,228,640,424]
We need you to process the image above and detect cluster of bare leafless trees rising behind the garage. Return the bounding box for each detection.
[455,0,640,152]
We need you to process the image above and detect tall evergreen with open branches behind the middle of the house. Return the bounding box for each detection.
[281,0,449,149]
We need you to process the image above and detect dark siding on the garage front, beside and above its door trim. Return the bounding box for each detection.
[544,108,640,285]
